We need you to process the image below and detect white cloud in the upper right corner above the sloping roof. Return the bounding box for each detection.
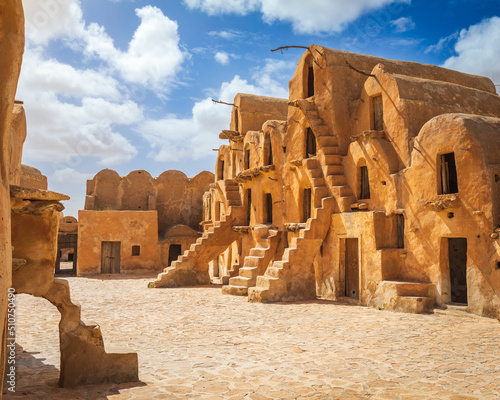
[443,17,500,84]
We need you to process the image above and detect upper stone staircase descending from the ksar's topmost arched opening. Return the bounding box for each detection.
[292,99,356,212]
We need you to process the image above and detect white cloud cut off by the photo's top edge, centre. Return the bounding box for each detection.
[184,0,411,34]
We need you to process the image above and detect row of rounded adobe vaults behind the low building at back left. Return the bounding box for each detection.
[85,169,214,231]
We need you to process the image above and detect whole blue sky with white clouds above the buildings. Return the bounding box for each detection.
[17,0,500,216]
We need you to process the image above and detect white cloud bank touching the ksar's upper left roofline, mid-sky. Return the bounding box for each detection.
[138,60,295,162]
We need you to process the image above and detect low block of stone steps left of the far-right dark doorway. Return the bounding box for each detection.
[370,281,436,314]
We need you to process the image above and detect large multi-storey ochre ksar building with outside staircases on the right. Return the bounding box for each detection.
[153,45,500,318]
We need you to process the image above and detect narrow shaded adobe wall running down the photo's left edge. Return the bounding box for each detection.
[0,0,24,390]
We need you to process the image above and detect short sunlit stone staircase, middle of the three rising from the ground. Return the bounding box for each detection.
[222,229,281,296]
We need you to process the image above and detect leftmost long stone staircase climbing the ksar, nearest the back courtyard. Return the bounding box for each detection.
[149,179,243,288]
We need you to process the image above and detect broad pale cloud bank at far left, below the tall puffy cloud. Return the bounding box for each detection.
[17,49,143,169]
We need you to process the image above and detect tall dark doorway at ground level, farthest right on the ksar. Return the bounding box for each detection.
[448,238,467,304]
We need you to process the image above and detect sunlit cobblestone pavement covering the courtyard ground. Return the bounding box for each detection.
[4,277,500,400]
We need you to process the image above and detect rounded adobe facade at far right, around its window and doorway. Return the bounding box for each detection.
[401,114,500,318]
